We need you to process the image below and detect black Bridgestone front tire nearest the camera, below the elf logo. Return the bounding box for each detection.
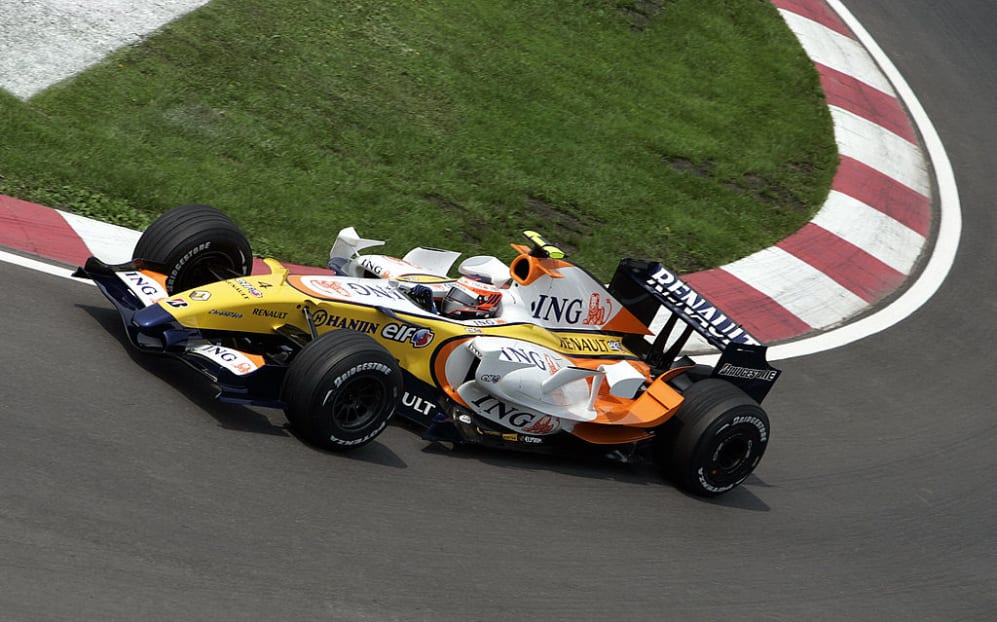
[282,330,402,451]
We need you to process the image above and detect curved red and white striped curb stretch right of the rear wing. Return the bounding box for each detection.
[672,0,932,342]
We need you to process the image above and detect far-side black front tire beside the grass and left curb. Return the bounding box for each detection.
[133,205,253,294]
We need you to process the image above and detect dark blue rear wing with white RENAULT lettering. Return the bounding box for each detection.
[609,259,781,402]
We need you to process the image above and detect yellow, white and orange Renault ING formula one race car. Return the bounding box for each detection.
[75,205,780,496]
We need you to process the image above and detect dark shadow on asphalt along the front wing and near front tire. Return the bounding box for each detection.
[76,305,407,468]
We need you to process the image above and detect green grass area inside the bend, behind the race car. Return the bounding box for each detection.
[0,0,837,277]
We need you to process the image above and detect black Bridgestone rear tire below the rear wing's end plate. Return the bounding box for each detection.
[659,378,770,497]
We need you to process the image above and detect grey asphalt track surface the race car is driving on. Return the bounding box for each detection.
[0,0,997,621]
